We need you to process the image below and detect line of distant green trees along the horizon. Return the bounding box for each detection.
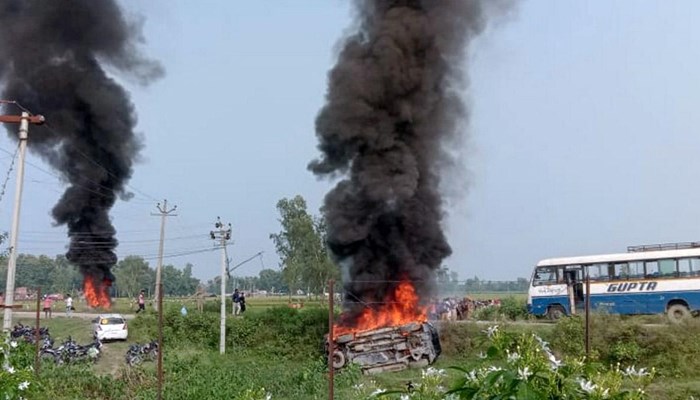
[0,196,529,298]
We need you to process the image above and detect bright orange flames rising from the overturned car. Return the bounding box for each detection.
[333,281,428,337]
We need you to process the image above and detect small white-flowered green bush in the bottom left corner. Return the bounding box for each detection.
[0,334,36,400]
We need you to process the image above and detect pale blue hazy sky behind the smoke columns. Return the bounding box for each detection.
[0,0,700,280]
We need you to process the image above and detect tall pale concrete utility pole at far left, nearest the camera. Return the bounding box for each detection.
[0,112,44,331]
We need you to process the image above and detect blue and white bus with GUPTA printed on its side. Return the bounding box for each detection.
[527,242,700,321]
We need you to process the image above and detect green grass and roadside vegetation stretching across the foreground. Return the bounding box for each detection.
[4,299,700,400]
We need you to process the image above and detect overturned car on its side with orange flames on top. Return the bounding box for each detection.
[325,282,441,374]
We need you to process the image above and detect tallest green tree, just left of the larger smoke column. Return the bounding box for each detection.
[270,196,339,293]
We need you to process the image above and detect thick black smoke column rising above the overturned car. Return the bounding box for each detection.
[309,0,498,322]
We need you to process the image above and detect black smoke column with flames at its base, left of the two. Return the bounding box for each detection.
[0,0,162,306]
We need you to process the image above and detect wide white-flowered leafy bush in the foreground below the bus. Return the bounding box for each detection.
[366,326,654,400]
